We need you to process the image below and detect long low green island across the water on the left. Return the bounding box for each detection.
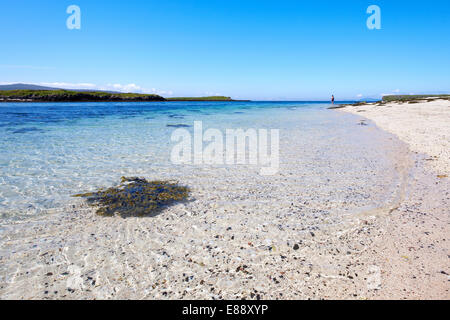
[0,90,236,102]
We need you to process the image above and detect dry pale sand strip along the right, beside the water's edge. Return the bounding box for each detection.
[341,98,450,299]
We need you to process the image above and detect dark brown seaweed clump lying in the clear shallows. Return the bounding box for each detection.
[74,177,190,217]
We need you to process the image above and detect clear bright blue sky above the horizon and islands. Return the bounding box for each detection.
[0,0,450,100]
